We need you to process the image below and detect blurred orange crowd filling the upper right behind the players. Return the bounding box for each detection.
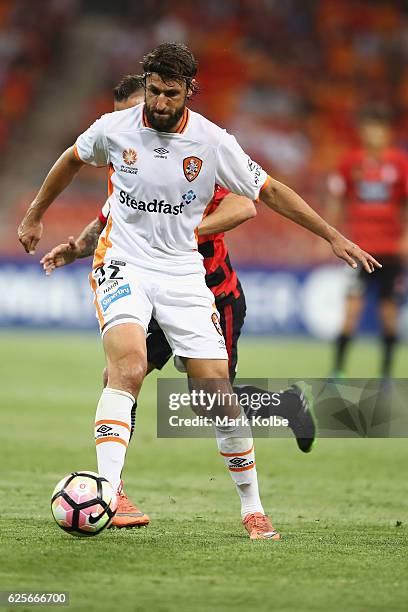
[79,0,408,176]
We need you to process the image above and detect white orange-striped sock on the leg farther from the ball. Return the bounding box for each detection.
[215,427,265,518]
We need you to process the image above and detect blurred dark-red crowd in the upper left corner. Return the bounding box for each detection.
[0,0,77,155]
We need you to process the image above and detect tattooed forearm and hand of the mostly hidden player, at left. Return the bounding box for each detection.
[41,218,105,276]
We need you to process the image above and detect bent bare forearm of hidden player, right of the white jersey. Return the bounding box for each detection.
[197,193,256,236]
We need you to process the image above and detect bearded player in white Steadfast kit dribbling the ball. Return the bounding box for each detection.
[19,43,380,540]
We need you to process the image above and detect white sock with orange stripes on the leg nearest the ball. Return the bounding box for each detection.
[95,387,135,491]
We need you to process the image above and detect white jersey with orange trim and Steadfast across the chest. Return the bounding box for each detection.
[75,104,267,275]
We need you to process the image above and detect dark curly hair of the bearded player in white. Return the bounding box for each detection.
[142,43,198,93]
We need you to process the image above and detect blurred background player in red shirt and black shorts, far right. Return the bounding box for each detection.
[327,106,408,378]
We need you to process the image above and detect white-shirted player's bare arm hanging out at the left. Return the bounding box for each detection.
[18,147,84,255]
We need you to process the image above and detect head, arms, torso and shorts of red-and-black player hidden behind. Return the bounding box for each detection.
[42,75,256,381]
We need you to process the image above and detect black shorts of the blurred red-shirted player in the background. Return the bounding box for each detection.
[349,255,403,300]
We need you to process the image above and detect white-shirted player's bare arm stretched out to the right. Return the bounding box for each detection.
[260,179,381,273]
